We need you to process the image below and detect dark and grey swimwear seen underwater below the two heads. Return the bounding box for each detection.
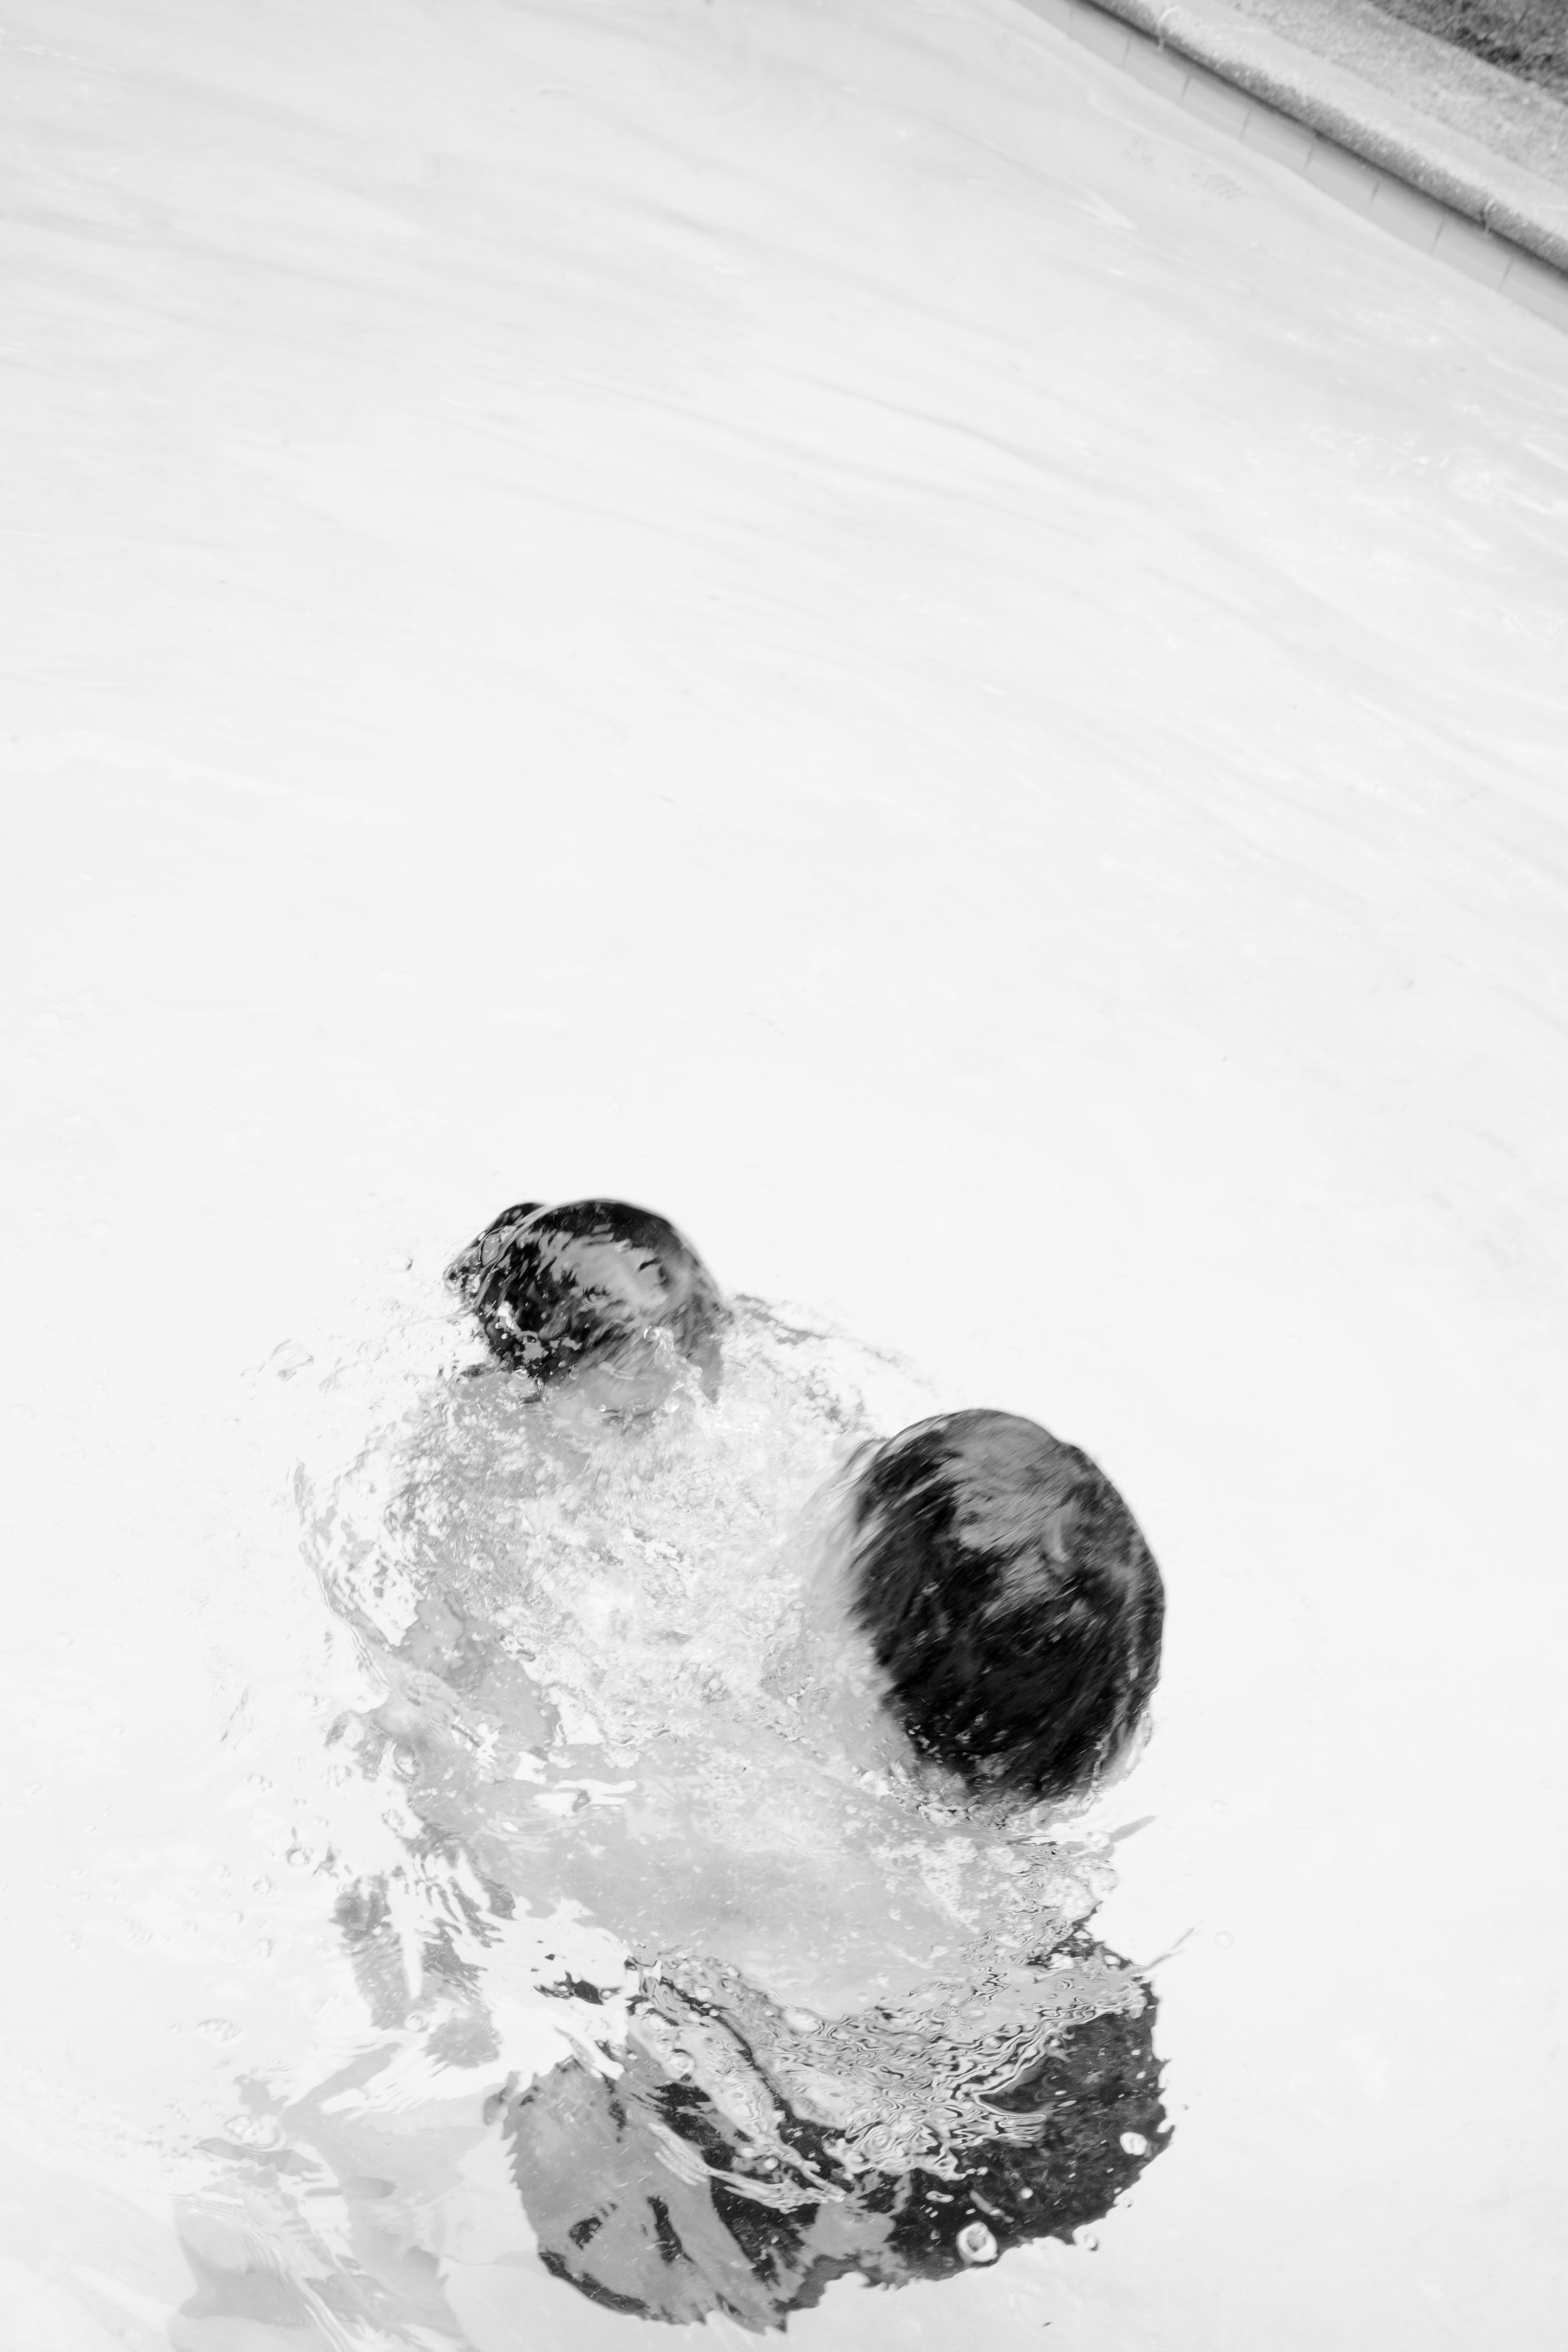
[499,1954,1163,2329]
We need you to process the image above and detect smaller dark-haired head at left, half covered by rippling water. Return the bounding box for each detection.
[447,1200,724,1385]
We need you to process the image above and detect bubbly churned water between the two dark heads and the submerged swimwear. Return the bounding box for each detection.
[288,1301,1145,2208]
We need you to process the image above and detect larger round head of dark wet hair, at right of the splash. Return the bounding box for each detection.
[851,1411,1163,1797]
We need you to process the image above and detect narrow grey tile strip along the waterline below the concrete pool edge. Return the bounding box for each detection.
[1020,0,1568,334]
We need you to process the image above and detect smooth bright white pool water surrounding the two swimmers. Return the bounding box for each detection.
[0,0,1568,2352]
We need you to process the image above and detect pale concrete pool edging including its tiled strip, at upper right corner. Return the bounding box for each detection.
[1022,0,1568,332]
